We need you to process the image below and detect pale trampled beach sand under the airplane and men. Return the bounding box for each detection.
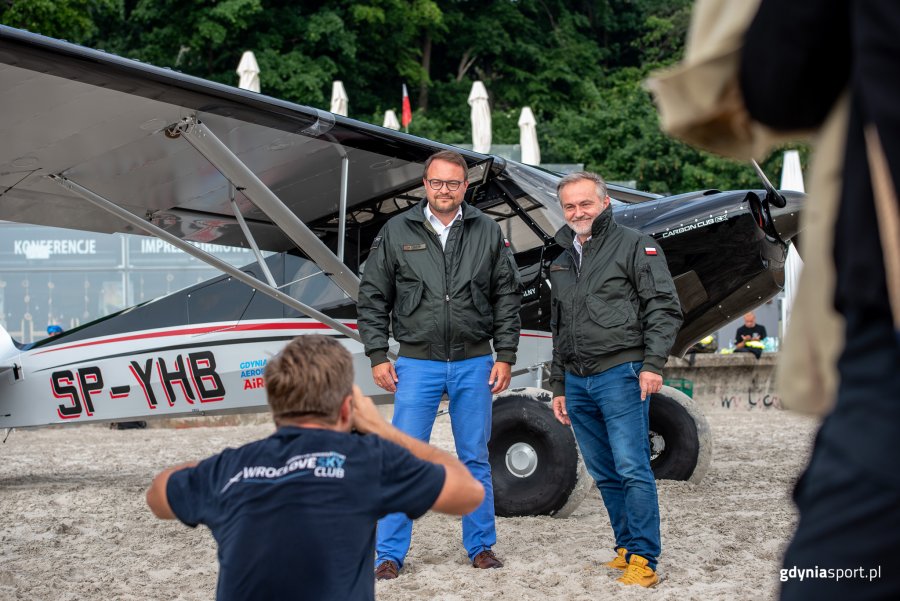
[0,411,816,601]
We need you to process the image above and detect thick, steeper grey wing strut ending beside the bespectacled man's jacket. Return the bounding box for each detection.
[171,116,359,300]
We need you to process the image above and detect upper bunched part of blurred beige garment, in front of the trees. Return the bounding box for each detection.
[646,0,810,160]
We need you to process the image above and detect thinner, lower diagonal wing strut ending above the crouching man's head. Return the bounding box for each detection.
[49,175,361,342]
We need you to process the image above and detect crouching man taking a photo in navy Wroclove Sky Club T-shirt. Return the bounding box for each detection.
[147,335,484,601]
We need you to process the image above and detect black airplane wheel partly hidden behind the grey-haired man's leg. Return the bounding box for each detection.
[650,386,712,482]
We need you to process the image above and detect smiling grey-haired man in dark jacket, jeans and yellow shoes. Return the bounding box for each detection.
[550,171,682,587]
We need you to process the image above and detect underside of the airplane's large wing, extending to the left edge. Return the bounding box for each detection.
[0,26,492,251]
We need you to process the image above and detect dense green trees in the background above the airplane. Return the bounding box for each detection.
[0,0,807,193]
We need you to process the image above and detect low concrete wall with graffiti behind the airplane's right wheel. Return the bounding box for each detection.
[663,353,782,411]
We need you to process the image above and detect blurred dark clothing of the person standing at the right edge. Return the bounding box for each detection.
[740,0,900,600]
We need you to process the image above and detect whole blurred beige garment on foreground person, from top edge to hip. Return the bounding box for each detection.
[647,0,849,414]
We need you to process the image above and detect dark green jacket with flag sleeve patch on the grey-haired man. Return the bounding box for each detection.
[550,205,682,396]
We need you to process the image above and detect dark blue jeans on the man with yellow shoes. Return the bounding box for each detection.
[566,361,660,570]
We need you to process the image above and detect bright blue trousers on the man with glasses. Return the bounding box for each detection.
[375,355,497,567]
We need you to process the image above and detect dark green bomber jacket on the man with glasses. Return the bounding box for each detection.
[356,200,522,367]
